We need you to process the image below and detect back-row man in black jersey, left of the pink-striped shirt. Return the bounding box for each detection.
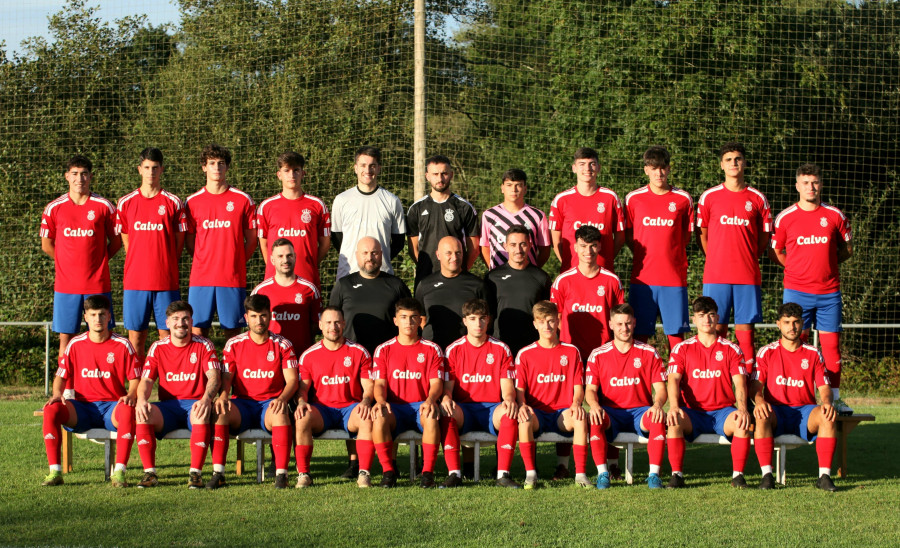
[406,155,480,289]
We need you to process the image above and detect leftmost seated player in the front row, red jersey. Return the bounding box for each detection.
[41,295,141,487]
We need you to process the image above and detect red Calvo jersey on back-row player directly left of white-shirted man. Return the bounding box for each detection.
[256,194,331,286]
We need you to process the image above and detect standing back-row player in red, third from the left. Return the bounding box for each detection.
[185,145,257,337]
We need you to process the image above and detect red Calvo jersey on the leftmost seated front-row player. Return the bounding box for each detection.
[56,333,141,402]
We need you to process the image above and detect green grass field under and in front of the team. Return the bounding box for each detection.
[0,398,900,546]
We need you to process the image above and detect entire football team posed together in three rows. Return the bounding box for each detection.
[40,143,853,491]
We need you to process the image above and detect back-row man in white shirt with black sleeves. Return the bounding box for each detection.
[331,146,406,279]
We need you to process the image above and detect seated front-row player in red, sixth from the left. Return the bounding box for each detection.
[441,299,520,489]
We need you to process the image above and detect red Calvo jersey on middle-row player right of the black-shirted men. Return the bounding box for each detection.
[550,267,625,356]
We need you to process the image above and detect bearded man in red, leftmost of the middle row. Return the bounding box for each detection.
[251,238,322,352]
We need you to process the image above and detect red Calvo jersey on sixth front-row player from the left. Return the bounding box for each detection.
[444,337,516,403]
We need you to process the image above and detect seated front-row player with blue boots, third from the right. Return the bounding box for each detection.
[585,304,666,489]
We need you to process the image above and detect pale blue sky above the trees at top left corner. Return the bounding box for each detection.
[0,0,180,55]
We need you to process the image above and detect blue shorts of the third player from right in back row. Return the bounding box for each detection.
[628,283,691,335]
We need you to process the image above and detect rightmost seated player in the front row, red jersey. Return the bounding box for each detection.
[750,303,837,491]
